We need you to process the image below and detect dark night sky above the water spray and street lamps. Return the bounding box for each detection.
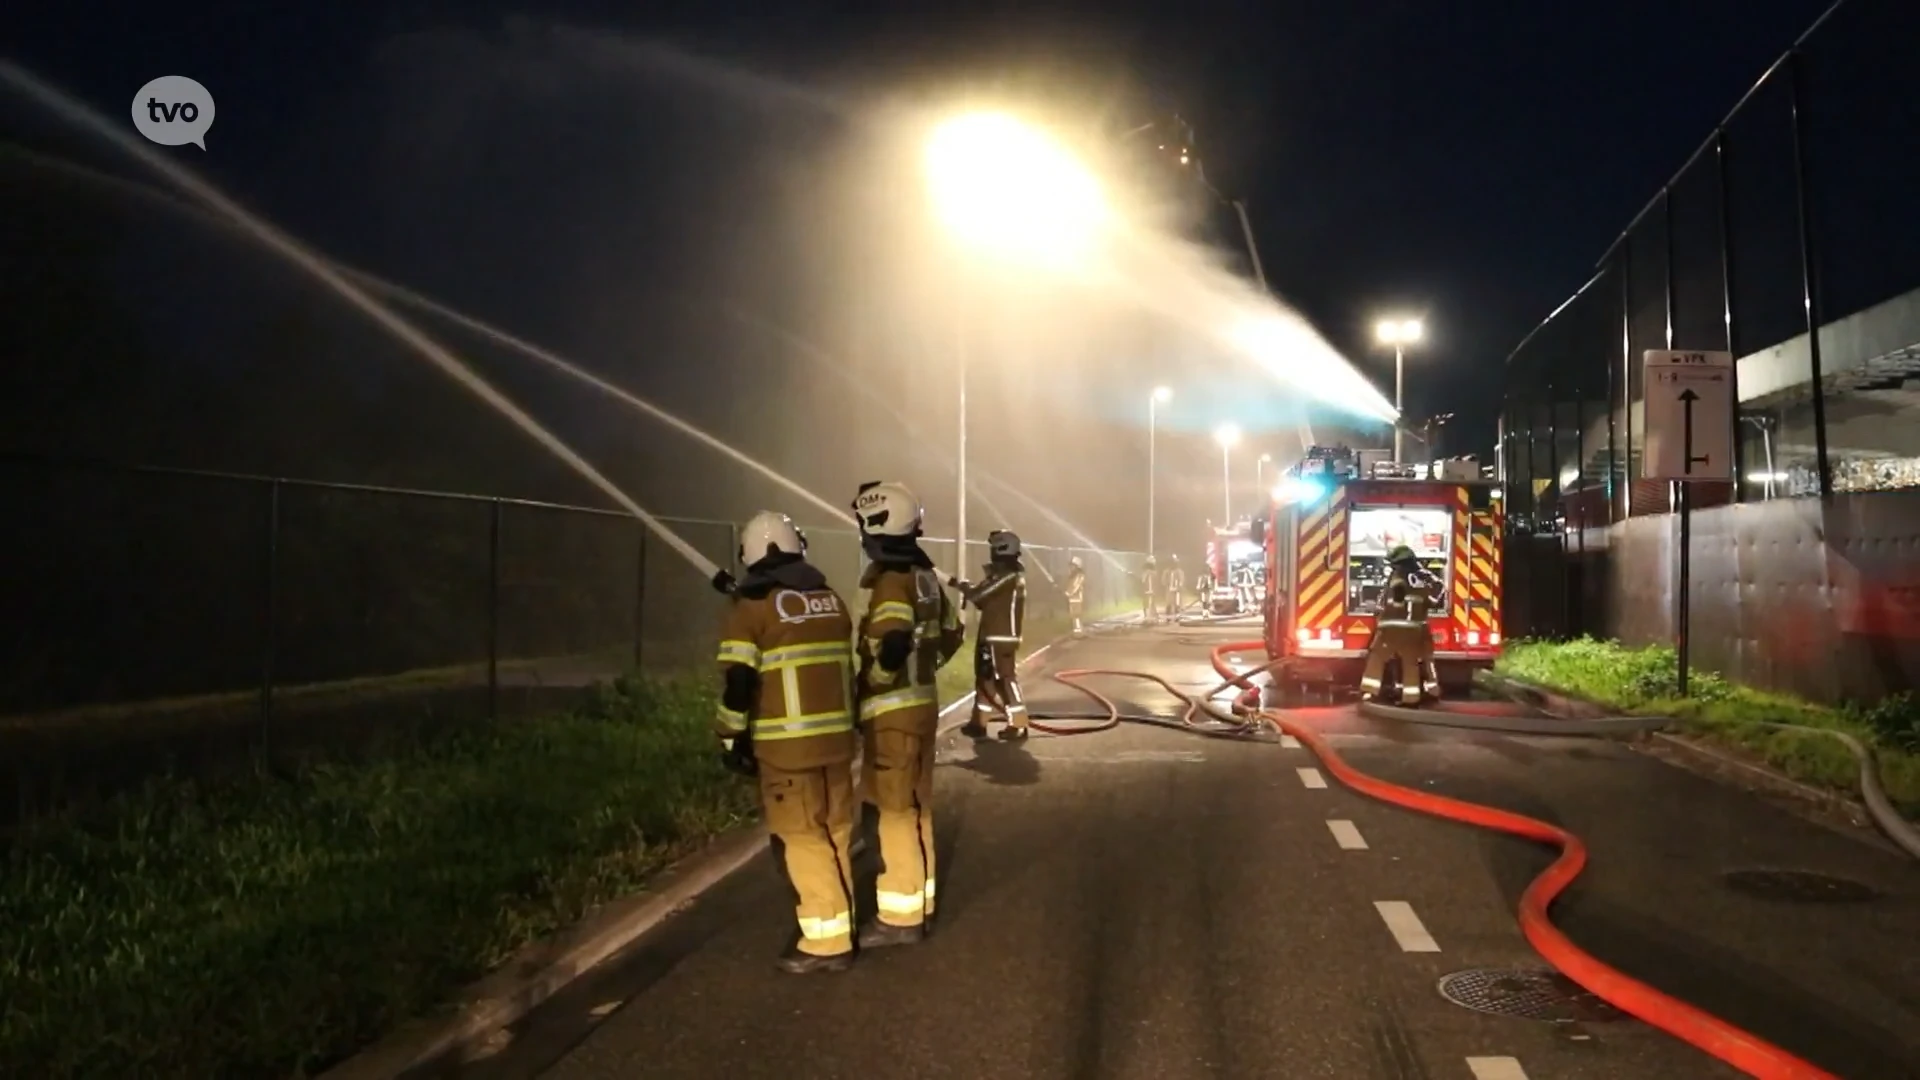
[8,0,1826,549]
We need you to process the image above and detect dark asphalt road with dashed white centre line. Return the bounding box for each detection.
[424,630,1920,1080]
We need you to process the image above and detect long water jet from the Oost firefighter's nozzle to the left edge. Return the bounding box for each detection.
[0,60,720,577]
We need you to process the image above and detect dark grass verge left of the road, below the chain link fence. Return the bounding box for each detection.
[0,680,755,1078]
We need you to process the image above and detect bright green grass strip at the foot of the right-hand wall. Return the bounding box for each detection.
[1496,638,1920,819]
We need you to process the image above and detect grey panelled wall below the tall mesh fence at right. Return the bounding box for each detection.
[1536,492,1920,701]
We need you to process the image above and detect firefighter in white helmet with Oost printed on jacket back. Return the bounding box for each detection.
[716,511,854,974]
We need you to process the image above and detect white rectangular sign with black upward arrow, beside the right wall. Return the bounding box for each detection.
[1640,350,1734,482]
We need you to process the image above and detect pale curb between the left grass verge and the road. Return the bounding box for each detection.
[319,611,1121,1080]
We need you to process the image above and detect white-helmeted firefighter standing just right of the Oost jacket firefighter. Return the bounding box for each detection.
[852,480,966,949]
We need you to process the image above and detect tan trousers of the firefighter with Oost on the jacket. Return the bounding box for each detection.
[760,761,854,957]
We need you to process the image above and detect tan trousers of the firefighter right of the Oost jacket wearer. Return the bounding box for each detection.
[860,709,939,926]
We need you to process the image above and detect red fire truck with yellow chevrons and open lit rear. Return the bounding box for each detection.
[1252,446,1505,696]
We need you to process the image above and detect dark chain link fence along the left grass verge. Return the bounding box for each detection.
[0,451,1140,821]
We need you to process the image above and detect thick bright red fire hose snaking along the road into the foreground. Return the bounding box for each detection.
[1188,642,1839,1080]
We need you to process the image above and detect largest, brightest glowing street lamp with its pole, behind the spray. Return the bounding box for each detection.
[924,113,1108,577]
